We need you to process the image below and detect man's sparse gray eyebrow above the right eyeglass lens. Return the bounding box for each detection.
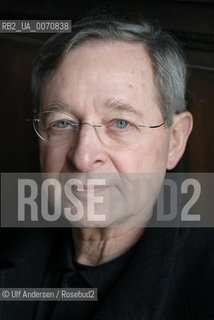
[104,98,143,117]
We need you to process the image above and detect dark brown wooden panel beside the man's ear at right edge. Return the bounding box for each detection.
[186,69,214,172]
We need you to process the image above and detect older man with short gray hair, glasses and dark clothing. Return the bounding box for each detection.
[1,15,214,320]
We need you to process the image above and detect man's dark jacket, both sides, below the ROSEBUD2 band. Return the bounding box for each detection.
[0,228,214,320]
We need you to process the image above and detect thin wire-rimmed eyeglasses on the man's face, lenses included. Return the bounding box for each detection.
[29,110,165,147]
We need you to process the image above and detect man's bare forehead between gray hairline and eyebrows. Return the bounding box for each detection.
[42,40,158,116]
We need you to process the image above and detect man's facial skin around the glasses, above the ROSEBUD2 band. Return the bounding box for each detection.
[40,41,174,225]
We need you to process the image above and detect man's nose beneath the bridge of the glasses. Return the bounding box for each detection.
[67,122,108,172]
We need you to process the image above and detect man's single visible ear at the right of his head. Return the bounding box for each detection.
[167,111,193,170]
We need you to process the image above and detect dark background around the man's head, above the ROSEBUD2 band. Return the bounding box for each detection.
[0,0,214,172]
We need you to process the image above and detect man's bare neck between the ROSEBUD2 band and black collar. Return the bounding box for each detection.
[72,227,144,266]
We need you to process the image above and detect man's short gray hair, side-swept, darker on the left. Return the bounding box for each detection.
[32,18,186,127]
